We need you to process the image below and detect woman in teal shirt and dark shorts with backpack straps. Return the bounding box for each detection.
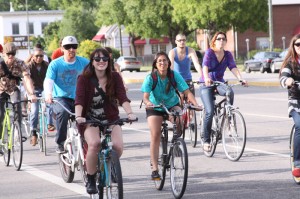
[141,52,198,180]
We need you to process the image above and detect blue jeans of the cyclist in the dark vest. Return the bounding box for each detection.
[30,90,53,130]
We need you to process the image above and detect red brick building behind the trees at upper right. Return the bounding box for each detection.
[197,0,300,59]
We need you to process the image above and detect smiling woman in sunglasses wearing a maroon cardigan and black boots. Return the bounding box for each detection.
[75,48,136,194]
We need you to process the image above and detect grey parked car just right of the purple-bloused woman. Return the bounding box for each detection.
[244,51,279,73]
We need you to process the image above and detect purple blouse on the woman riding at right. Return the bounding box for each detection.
[200,48,236,82]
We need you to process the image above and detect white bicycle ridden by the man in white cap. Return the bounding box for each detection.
[53,99,87,184]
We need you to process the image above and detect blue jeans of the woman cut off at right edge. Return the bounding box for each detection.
[291,110,300,168]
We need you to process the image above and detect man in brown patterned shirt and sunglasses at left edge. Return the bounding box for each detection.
[0,42,36,151]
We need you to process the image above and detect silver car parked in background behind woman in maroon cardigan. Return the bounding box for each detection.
[117,56,142,72]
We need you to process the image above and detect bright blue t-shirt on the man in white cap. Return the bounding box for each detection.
[46,56,89,99]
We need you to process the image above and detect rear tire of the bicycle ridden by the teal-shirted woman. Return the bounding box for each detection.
[154,130,168,191]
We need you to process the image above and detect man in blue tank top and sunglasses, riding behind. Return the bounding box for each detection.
[169,34,202,95]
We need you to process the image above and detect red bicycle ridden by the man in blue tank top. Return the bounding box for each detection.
[182,81,198,148]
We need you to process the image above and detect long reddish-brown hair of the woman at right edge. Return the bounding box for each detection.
[279,34,300,74]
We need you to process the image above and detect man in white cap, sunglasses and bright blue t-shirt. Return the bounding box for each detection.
[44,36,89,153]
